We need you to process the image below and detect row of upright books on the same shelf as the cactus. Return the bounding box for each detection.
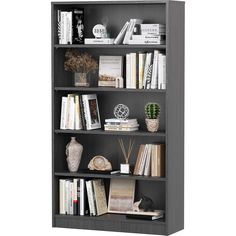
[60,94,101,130]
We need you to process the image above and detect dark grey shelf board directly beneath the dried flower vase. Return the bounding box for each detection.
[54,87,166,93]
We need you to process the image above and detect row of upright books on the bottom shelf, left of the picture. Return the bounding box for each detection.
[59,179,107,216]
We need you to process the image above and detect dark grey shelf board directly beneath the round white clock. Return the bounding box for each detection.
[54,44,166,49]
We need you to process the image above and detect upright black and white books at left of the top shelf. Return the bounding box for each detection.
[57,9,84,44]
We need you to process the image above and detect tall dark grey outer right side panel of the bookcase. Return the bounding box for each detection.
[166,1,184,234]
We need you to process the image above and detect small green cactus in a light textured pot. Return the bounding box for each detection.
[144,102,160,132]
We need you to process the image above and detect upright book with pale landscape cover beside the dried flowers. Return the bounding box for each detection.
[98,56,123,87]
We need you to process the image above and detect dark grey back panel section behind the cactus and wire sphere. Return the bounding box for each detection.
[54,92,166,131]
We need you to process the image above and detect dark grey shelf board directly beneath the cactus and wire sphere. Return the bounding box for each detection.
[55,129,165,137]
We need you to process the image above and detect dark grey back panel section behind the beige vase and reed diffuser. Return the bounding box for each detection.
[54,134,165,172]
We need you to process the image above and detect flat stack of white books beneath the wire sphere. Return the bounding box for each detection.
[104,118,139,131]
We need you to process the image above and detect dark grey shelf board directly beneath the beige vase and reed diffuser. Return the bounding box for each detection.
[54,172,166,182]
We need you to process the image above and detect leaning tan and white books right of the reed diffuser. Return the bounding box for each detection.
[133,144,165,177]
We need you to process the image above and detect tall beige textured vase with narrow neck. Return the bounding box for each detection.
[66,137,83,172]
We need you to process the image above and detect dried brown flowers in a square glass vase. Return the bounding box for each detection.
[64,49,98,87]
